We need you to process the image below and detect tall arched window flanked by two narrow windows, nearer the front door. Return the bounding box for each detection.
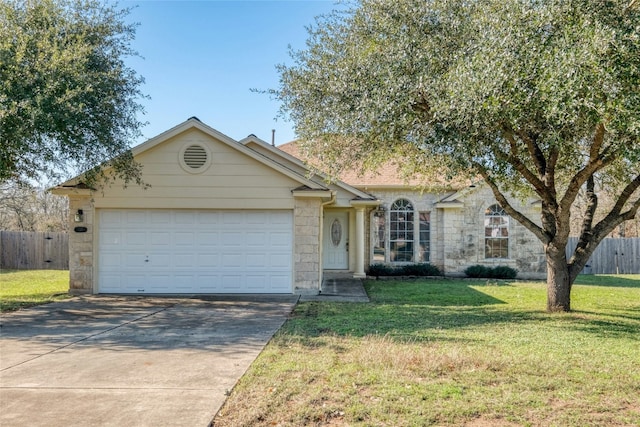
[389,199,414,262]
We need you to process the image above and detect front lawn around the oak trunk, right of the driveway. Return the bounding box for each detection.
[213,275,640,427]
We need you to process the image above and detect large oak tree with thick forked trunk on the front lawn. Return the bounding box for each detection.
[273,0,640,311]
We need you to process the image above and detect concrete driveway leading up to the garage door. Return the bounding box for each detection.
[0,296,297,427]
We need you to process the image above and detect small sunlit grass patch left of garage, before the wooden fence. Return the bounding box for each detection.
[0,270,69,312]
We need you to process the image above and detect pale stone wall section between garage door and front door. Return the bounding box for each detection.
[293,198,321,294]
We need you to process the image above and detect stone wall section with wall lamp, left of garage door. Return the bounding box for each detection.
[69,195,95,295]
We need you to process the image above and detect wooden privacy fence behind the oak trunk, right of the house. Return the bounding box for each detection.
[567,237,640,274]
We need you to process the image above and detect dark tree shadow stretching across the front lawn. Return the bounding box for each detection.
[283,280,640,345]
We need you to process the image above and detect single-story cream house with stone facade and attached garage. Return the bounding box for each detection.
[53,117,545,294]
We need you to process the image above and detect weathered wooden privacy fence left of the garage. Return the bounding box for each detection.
[0,231,69,270]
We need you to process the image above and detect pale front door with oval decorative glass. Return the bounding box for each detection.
[322,211,349,270]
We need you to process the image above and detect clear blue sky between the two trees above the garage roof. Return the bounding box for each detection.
[119,0,337,144]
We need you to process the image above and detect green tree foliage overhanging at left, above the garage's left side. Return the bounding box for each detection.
[0,0,143,185]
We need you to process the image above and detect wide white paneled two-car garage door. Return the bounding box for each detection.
[98,209,293,294]
